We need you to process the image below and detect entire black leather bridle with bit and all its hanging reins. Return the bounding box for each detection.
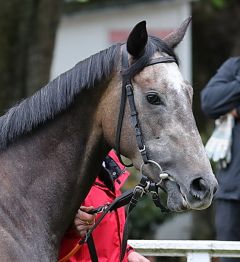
[58,46,176,262]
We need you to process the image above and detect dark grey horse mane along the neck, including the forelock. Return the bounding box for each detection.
[0,37,176,150]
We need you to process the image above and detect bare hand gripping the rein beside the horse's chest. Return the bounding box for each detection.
[74,206,96,237]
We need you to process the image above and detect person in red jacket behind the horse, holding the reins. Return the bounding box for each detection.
[59,150,149,262]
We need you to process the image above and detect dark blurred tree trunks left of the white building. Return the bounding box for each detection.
[0,0,63,114]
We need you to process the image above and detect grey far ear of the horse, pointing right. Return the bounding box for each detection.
[162,16,192,48]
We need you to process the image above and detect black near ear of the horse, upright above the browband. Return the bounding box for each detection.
[127,21,148,58]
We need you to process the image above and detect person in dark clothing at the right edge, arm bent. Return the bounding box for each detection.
[201,57,240,262]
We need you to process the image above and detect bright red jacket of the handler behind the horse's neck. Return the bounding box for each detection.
[59,151,133,262]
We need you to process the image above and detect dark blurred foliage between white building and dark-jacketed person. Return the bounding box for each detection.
[192,0,240,132]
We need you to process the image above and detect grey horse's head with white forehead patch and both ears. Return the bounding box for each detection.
[101,18,217,211]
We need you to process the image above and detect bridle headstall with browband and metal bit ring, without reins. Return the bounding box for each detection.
[115,46,176,185]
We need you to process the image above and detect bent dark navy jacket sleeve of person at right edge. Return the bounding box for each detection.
[201,57,240,119]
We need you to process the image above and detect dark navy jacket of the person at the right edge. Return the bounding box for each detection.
[201,57,240,200]
